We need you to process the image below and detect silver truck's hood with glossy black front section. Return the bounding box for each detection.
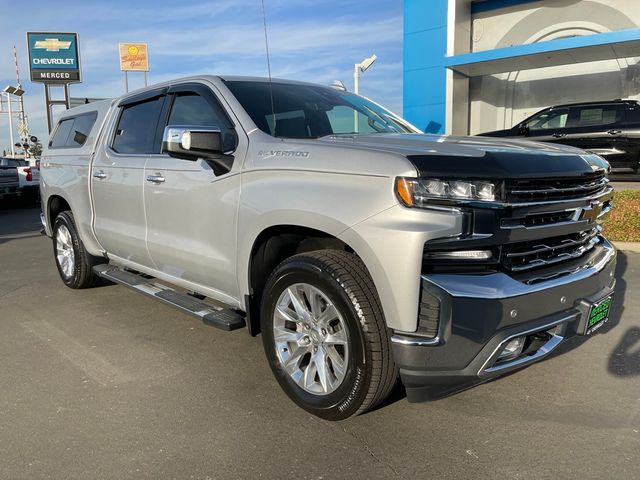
[319,134,609,179]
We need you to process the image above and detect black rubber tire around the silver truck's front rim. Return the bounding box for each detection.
[260,250,398,420]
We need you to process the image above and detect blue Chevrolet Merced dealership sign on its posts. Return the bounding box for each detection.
[27,32,82,133]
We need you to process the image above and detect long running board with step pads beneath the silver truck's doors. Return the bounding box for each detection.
[93,264,245,331]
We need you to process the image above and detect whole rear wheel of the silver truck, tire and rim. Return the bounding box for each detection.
[53,211,105,289]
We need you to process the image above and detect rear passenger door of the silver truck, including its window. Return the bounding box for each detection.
[91,89,166,267]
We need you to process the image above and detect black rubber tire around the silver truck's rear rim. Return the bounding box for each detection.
[53,211,106,289]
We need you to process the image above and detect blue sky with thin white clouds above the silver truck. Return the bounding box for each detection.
[0,0,402,151]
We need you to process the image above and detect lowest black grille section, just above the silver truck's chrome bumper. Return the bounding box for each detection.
[501,227,600,272]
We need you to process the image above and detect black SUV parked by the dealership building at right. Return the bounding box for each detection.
[480,100,640,173]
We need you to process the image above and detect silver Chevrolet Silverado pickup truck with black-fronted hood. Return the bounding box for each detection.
[41,76,616,420]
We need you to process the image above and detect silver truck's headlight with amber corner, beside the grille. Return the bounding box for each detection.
[396,177,498,207]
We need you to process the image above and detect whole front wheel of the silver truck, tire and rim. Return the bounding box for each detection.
[261,250,398,420]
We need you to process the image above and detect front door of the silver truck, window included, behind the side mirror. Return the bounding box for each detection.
[144,83,247,300]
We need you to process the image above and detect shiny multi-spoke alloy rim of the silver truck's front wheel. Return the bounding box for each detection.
[273,283,349,395]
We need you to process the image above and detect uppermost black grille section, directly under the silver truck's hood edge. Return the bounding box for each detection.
[505,172,608,203]
